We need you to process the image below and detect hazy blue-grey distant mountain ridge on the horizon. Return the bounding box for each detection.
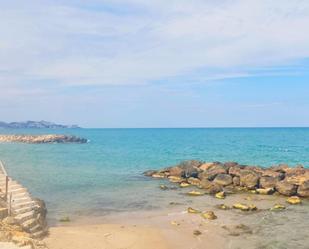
[0,120,80,129]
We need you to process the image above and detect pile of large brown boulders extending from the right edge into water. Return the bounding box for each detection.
[144,160,309,198]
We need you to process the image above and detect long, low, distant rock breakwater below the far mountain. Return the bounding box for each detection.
[0,135,88,144]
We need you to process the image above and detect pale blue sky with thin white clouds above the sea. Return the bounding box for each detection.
[0,0,309,128]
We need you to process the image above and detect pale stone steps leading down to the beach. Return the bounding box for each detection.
[0,161,45,238]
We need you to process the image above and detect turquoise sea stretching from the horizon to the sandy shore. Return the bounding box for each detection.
[0,128,309,221]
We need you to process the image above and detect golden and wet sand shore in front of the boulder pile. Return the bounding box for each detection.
[45,194,309,249]
